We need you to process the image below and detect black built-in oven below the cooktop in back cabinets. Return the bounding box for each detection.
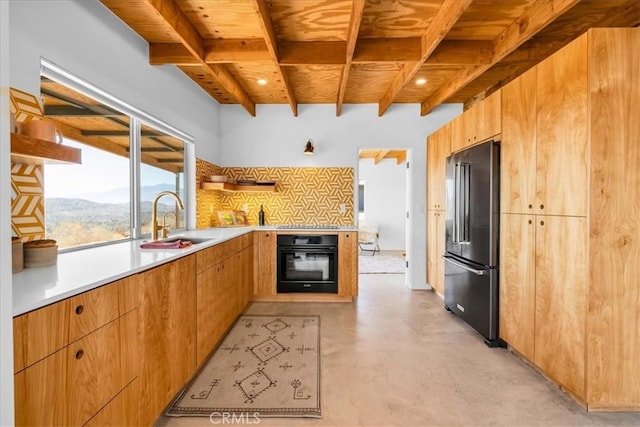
[277,234,338,294]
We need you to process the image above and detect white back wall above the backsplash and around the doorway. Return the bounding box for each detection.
[220,104,462,289]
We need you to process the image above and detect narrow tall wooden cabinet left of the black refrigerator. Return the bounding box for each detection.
[427,125,451,296]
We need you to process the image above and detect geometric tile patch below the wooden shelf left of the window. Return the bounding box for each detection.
[11,162,45,242]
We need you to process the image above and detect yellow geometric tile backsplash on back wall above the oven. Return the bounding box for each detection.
[196,160,354,228]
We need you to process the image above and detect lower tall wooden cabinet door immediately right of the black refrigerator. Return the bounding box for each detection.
[498,214,536,361]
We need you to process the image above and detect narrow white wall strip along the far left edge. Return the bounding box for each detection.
[0,1,14,426]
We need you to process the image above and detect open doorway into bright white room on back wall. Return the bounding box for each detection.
[356,148,411,286]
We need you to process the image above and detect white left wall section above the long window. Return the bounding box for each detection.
[6,0,220,163]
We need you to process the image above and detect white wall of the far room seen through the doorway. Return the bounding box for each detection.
[358,159,407,251]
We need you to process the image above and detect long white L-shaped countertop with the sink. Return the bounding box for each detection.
[13,225,357,316]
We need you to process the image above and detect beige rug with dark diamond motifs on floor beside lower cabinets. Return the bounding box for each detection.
[165,314,321,421]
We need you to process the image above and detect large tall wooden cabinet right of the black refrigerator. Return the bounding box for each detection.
[500,28,640,410]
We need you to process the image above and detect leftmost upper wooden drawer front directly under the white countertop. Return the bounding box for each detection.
[13,300,69,372]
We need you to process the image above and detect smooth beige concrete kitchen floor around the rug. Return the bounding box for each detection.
[157,274,640,427]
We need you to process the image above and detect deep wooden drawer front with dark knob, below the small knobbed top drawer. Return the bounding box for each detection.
[66,321,126,425]
